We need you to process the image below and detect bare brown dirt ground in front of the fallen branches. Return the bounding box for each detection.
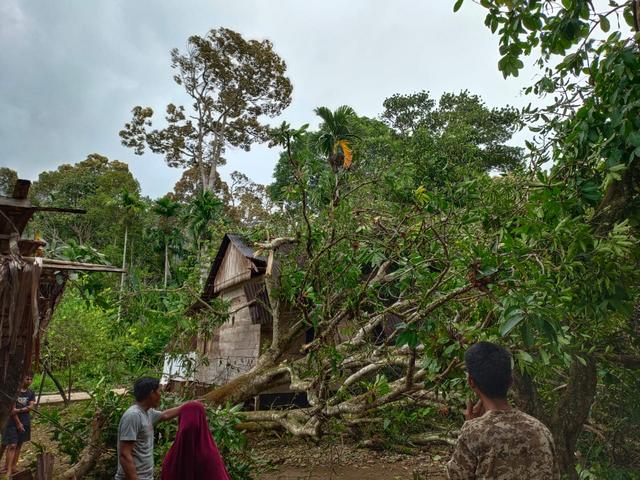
[12,425,450,480]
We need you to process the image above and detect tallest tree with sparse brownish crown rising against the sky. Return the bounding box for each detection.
[120,28,292,192]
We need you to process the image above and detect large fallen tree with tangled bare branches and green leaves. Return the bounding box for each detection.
[196,63,638,475]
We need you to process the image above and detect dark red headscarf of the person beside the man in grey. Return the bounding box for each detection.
[160,402,231,480]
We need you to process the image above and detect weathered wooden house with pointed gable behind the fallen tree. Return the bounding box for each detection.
[189,234,305,385]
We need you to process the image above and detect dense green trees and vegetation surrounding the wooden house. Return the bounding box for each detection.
[5,0,640,479]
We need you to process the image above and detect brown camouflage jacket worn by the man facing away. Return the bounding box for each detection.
[447,409,559,480]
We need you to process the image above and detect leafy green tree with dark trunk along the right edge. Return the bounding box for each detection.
[454,0,640,479]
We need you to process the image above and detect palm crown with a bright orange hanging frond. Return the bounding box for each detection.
[315,105,358,173]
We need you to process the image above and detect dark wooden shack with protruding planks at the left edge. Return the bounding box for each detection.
[0,180,122,426]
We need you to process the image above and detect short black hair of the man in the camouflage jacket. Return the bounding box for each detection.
[464,342,512,398]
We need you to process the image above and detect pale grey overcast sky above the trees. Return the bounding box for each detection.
[0,0,534,197]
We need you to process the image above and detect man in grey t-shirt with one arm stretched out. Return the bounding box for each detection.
[115,377,186,480]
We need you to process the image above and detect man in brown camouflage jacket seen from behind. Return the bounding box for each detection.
[447,342,559,480]
